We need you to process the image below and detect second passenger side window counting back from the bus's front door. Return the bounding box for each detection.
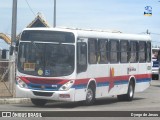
[98,39,108,64]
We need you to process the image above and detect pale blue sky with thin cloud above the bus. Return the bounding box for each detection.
[0,0,160,48]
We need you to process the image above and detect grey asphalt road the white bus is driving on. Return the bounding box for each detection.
[0,80,160,120]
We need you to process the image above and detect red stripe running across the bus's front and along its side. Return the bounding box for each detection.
[19,74,151,85]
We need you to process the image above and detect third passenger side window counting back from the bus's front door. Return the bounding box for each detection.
[110,40,119,63]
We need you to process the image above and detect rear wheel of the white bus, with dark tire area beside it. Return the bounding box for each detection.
[117,81,134,101]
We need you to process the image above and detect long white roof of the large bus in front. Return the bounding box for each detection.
[24,27,151,41]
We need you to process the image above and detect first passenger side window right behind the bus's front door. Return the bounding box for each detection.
[88,38,97,64]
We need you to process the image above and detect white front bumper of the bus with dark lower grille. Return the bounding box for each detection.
[16,85,75,101]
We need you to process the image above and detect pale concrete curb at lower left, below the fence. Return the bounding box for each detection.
[0,98,31,104]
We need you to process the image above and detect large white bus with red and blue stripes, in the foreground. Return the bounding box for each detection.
[16,28,152,106]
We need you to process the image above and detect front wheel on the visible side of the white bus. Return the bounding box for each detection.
[83,84,95,105]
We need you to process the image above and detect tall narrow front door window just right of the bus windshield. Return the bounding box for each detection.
[77,42,87,73]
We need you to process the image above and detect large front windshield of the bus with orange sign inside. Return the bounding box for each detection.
[18,42,75,77]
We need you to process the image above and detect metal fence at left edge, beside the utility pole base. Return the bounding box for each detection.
[0,60,15,98]
